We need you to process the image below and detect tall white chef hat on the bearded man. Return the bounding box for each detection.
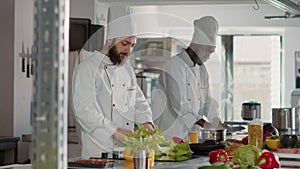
[107,6,136,39]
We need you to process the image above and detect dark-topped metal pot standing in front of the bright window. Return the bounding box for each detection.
[241,101,261,120]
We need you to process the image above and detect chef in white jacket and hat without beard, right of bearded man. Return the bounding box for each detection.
[152,16,227,141]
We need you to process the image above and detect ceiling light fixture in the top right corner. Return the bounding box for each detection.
[265,0,300,15]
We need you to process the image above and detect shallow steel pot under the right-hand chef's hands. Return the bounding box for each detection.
[199,129,226,142]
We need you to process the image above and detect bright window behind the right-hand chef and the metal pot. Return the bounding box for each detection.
[206,35,281,122]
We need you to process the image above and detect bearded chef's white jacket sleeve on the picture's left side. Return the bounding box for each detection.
[72,62,117,134]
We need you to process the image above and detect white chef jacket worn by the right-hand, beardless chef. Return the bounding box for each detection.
[152,51,219,141]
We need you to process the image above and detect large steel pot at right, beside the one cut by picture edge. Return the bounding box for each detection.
[272,108,296,133]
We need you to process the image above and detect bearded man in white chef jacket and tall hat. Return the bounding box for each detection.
[72,6,153,156]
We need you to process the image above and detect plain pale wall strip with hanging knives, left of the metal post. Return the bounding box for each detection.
[14,0,34,137]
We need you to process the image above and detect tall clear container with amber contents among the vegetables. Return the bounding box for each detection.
[248,118,263,149]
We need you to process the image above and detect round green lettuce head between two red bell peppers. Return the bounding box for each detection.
[234,145,260,169]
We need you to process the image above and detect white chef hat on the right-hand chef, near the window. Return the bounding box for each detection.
[191,16,219,46]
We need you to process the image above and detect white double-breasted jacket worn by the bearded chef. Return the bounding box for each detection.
[72,51,152,156]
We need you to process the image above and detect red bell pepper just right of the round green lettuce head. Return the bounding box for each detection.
[258,152,280,169]
